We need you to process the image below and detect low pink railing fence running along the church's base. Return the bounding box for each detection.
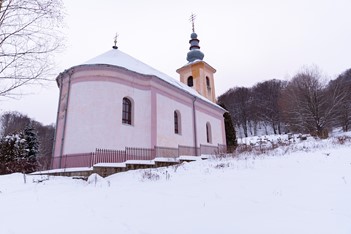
[51,145,230,169]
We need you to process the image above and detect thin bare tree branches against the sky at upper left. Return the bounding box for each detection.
[0,0,63,96]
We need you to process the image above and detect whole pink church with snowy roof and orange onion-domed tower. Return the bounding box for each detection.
[53,22,226,168]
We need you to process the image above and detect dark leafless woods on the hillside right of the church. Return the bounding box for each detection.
[218,68,351,138]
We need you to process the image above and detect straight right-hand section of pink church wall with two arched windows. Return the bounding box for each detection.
[157,79,225,147]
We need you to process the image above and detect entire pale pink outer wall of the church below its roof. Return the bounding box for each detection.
[55,65,225,156]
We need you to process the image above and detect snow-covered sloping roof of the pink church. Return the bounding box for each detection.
[83,49,222,109]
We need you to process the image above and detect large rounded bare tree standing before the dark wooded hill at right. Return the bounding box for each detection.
[282,68,345,138]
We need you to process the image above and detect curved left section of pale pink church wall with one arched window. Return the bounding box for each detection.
[64,81,151,154]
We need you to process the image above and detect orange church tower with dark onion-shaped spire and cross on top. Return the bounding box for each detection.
[177,14,216,103]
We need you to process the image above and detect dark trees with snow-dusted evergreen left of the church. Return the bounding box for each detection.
[0,112,55,174]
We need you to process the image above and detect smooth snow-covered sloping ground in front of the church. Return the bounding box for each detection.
[0,134,351,234]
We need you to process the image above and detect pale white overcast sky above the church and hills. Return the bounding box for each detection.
[0,0,351,124]
